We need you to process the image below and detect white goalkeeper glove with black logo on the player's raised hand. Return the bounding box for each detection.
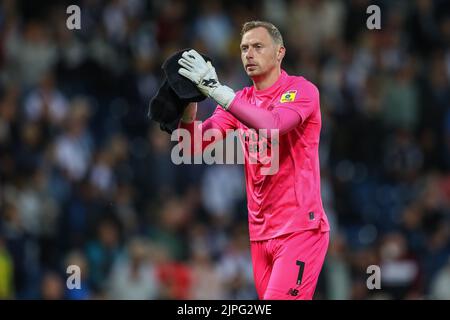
[178,50,235,110]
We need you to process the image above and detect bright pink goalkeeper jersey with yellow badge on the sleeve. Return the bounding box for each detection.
[180,70,329,241]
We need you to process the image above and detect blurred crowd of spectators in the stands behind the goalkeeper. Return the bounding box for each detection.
[0,0,450,299]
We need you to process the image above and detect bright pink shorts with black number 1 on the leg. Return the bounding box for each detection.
[250,229,329,300]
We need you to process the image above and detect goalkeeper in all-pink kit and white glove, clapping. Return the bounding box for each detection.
[178,21,329,299]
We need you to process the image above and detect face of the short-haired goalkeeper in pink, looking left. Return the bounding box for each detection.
[240,27,284,78]
